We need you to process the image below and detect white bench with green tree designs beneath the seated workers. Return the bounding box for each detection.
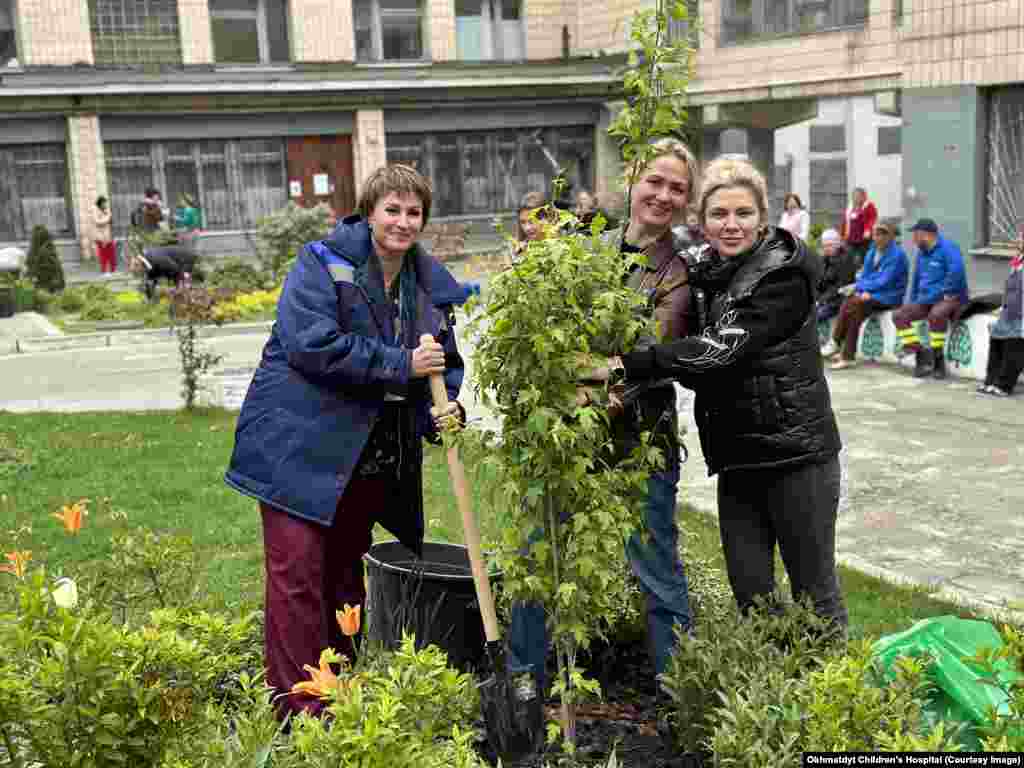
[818,311,998,381]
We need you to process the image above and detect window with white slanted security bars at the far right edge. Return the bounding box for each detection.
[987,86,1024,243]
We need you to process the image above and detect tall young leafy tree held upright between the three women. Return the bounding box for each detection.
[461,0,692,752]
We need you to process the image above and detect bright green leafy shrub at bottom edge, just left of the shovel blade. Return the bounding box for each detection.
[284,636,484,768]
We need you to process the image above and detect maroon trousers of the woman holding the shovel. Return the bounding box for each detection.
[260,478,390,717]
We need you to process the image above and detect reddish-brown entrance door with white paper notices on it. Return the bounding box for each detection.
[288,135,355,219]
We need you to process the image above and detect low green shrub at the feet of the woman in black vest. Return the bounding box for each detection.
[662,593,835,751]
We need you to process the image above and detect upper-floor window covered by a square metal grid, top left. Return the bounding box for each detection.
[89,0,181,67]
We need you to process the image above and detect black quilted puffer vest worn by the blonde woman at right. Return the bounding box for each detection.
[691,227,842,474]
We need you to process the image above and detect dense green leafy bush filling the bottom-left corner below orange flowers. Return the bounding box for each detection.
[0,568,226,768]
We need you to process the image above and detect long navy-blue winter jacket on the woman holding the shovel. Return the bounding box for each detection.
[225,216,465,551]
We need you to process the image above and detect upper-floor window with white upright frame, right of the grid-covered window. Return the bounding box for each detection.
[210,0,290,63]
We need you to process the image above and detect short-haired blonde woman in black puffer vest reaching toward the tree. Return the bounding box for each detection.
[595,154,847,630]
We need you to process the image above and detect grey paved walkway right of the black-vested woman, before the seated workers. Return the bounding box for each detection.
[680,364,1024,621]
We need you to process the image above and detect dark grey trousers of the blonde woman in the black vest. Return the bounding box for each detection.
[718,457,848,627]
